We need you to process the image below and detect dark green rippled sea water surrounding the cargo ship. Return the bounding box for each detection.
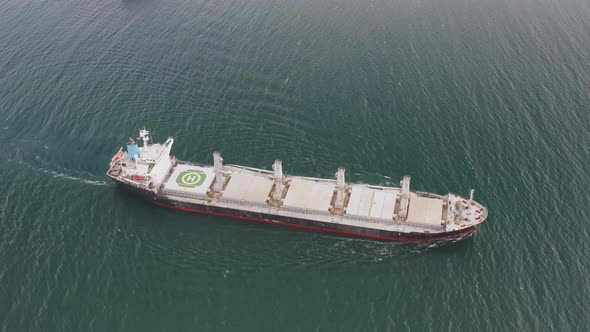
[0,0,590,332]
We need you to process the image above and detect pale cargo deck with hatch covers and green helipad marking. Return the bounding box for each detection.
[159,162,483,233]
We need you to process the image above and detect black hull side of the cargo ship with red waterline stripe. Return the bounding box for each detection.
[116,181,477,242]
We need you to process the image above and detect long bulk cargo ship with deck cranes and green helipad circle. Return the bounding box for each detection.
[107,129,488,242]
